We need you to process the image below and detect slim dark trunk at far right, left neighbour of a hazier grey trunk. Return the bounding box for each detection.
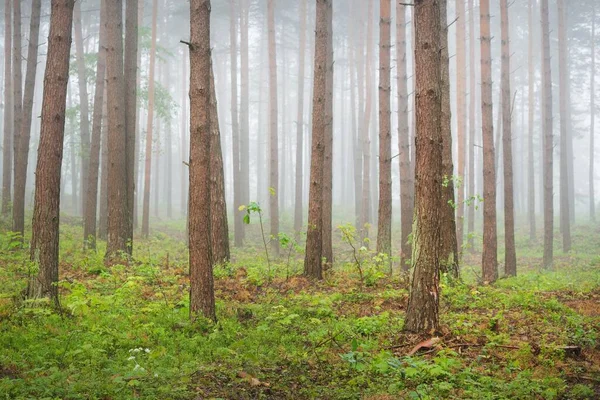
[541,0,554,269]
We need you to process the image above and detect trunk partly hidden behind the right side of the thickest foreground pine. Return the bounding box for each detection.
[439,1,458,278]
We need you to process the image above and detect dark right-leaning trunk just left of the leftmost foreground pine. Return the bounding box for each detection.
[13,0,42,238]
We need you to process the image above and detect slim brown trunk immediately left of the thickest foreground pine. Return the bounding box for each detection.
[396,0,414,272]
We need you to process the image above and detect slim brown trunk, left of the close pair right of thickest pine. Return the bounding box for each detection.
[479,0,498,283]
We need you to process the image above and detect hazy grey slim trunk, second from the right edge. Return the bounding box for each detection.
[557,0,571,253]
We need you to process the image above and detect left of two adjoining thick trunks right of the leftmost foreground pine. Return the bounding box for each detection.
[105,0,130,263]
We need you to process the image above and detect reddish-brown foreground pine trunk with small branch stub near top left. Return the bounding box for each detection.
[189,0,217,321]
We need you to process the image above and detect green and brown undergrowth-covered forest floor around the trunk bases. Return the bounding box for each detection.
[0,218,600,400]
